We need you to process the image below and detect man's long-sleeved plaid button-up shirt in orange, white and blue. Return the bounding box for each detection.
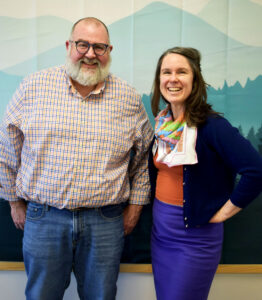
[0,66,153,209]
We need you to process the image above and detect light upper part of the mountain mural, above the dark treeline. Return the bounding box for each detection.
[0,0,262,136]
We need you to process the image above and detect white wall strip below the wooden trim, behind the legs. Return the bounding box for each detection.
[0,271,262,300]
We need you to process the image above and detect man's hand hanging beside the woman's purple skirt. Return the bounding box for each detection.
[124,204,143,235]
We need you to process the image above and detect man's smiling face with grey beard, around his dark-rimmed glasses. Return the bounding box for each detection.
[66,21,112,86]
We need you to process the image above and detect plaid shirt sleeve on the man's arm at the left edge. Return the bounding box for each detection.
[0,84,24,201]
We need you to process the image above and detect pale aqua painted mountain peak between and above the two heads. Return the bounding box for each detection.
[107,0,262,93]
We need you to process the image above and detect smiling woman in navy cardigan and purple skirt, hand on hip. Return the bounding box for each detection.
[149,47,262,300]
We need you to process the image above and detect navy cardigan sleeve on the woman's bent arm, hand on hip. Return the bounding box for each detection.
[207,117,262,208]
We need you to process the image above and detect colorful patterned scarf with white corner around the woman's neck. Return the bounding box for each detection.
[153,106,198,167]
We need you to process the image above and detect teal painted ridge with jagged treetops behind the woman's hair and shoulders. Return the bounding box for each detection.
[142,75,262,145]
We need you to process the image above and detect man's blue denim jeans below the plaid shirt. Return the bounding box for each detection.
[23,202,124,300]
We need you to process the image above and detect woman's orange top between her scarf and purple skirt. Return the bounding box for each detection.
[154,154,183,206]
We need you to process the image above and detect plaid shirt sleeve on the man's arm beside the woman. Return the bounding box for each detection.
[129,102,153,205]
